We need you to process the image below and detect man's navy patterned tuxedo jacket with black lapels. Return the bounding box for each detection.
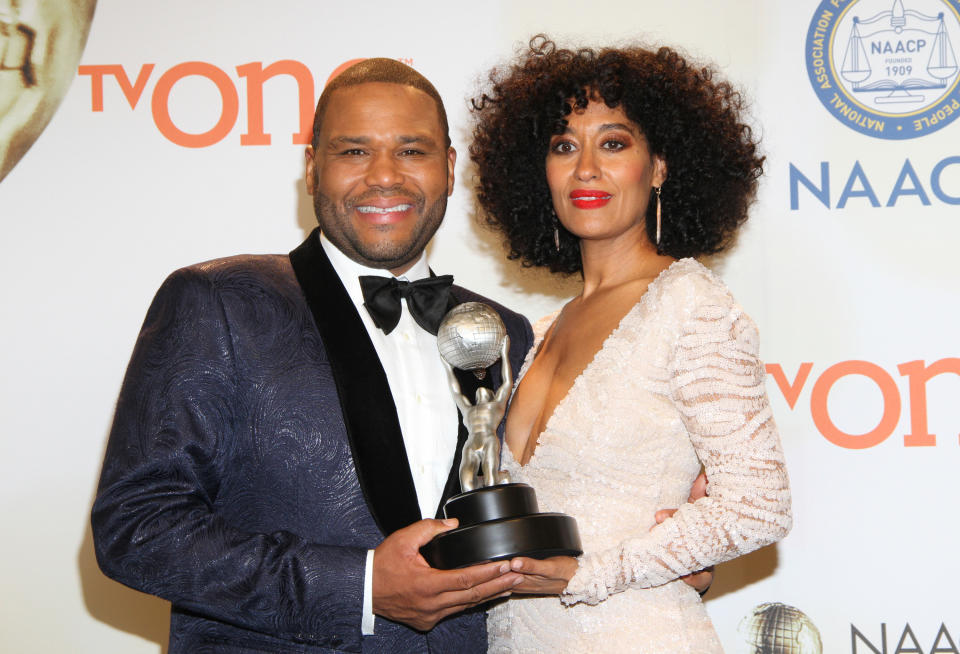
[92,232,532,654]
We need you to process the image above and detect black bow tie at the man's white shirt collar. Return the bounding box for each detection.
[360,275,453,334]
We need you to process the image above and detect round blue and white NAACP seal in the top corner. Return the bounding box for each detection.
[805,0,960,139]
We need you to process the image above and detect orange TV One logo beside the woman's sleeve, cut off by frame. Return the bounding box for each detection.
[766,358,960,452]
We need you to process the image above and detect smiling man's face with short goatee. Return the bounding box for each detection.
[306,82,456,274]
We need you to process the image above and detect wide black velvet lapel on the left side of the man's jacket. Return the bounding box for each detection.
[290,230,418,536]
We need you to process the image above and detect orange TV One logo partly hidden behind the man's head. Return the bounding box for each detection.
[77,58,413,148]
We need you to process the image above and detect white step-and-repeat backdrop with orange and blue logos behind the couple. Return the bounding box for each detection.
[0,0,960,654]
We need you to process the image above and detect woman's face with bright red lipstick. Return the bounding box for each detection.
[546,101,667,249]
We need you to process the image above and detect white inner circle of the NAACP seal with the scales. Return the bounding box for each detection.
[836,0,960,107]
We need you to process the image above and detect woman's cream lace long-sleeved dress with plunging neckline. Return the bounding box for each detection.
[487,259,791,654]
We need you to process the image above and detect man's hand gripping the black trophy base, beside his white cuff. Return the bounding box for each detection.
[373,520,523,631]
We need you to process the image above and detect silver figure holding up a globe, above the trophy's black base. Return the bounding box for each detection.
[438,302,513,492]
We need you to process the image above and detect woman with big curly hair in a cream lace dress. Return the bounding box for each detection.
[470,36,791,654]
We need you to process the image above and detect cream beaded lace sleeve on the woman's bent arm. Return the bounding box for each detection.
[561,286,791,604]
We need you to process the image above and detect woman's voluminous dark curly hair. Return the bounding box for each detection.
[470,35,763,273]
